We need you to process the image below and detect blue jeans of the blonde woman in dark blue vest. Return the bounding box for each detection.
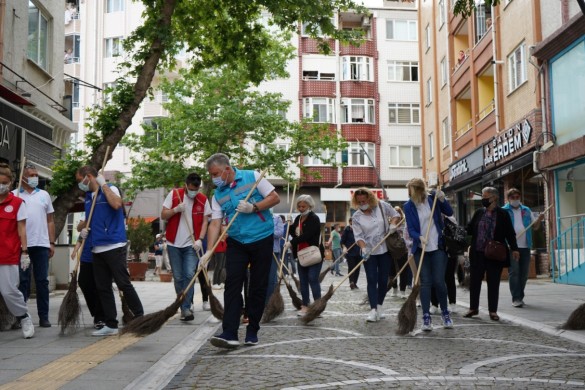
[414,249,447,314]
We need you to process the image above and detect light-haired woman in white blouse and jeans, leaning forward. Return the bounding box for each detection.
[350,188,400,322]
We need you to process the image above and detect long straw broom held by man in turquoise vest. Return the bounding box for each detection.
[120,171,266,336]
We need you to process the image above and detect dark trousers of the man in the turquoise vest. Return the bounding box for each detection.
[223,234,273,336]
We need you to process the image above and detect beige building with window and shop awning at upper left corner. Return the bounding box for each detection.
[0,0,75,182]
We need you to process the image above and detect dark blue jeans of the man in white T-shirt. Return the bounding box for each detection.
[18,246,49,320]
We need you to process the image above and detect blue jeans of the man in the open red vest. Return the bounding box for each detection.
[167,245,199,310]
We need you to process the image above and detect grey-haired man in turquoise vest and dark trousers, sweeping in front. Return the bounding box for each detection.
[200,153,280,348]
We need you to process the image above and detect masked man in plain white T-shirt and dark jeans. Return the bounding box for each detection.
[12,163,55,328]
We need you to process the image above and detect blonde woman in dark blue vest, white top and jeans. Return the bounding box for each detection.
[404,178,453,331]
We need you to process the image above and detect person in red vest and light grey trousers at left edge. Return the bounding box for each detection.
[0,163,35,339]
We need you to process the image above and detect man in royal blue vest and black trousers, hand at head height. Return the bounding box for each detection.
[75,166,144,337]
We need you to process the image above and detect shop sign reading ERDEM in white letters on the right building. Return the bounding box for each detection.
[484,119,532,166]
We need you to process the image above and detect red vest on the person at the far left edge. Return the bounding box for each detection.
[0,192,23,265]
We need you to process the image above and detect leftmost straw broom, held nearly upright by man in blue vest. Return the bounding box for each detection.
[57,146,110,334]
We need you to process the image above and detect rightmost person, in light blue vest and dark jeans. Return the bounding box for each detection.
[502,188,544,307]
